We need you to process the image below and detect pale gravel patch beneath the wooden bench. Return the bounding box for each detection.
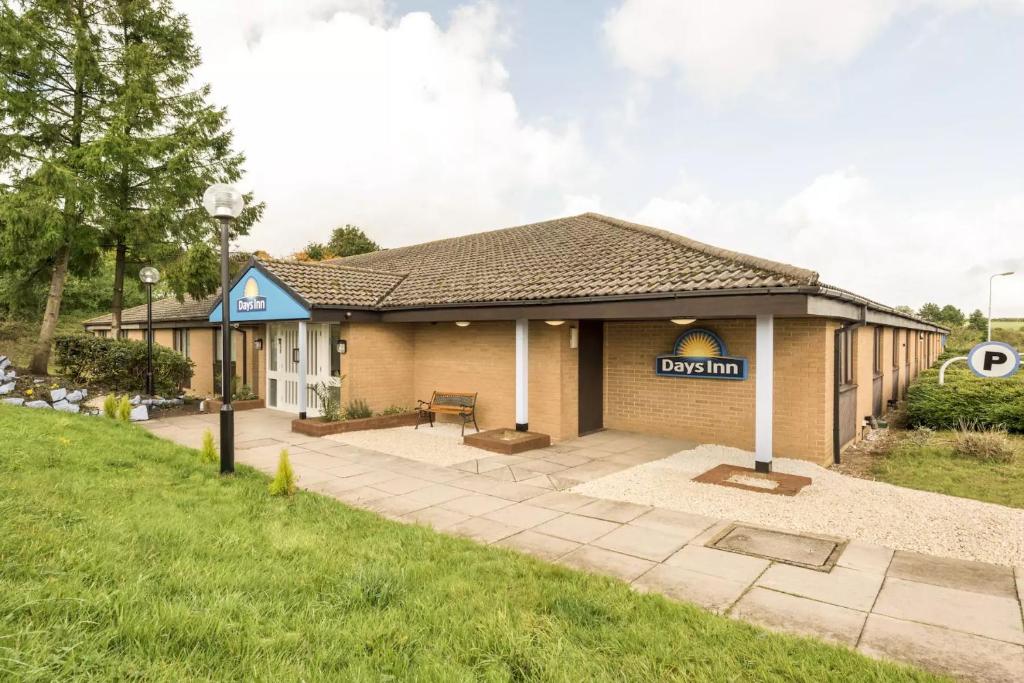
[326,423,495,467]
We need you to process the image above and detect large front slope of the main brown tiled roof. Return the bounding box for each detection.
[325,213,818,308]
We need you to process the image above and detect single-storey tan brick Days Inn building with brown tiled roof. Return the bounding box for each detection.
[85,214,947,467]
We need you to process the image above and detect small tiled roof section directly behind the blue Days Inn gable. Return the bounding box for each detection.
[259,260,406,306]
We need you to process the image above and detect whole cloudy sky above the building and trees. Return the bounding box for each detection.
[175,0,1024,316]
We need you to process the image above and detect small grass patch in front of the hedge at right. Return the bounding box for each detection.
[872,432,1024,508]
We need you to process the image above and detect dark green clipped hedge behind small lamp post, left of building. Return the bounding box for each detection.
[54,335,195,394]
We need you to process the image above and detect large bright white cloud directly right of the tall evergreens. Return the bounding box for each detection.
[179,0,591,253]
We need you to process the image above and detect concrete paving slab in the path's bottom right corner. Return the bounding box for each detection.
[857,614,1024,683]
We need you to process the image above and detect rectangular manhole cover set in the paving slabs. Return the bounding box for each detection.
[708,524,846,571]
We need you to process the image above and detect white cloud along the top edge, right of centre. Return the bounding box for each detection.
[604,0,1024,99]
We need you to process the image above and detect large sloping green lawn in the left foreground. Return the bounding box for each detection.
[0,405,932,681]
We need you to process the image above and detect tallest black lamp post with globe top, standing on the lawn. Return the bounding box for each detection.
[203,183,245,474]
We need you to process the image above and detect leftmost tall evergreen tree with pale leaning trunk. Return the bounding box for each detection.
[0,0,104,374]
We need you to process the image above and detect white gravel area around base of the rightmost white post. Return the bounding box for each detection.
[570,445,1024,566]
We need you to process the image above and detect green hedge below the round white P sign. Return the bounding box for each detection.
[906,353,1024,432]
